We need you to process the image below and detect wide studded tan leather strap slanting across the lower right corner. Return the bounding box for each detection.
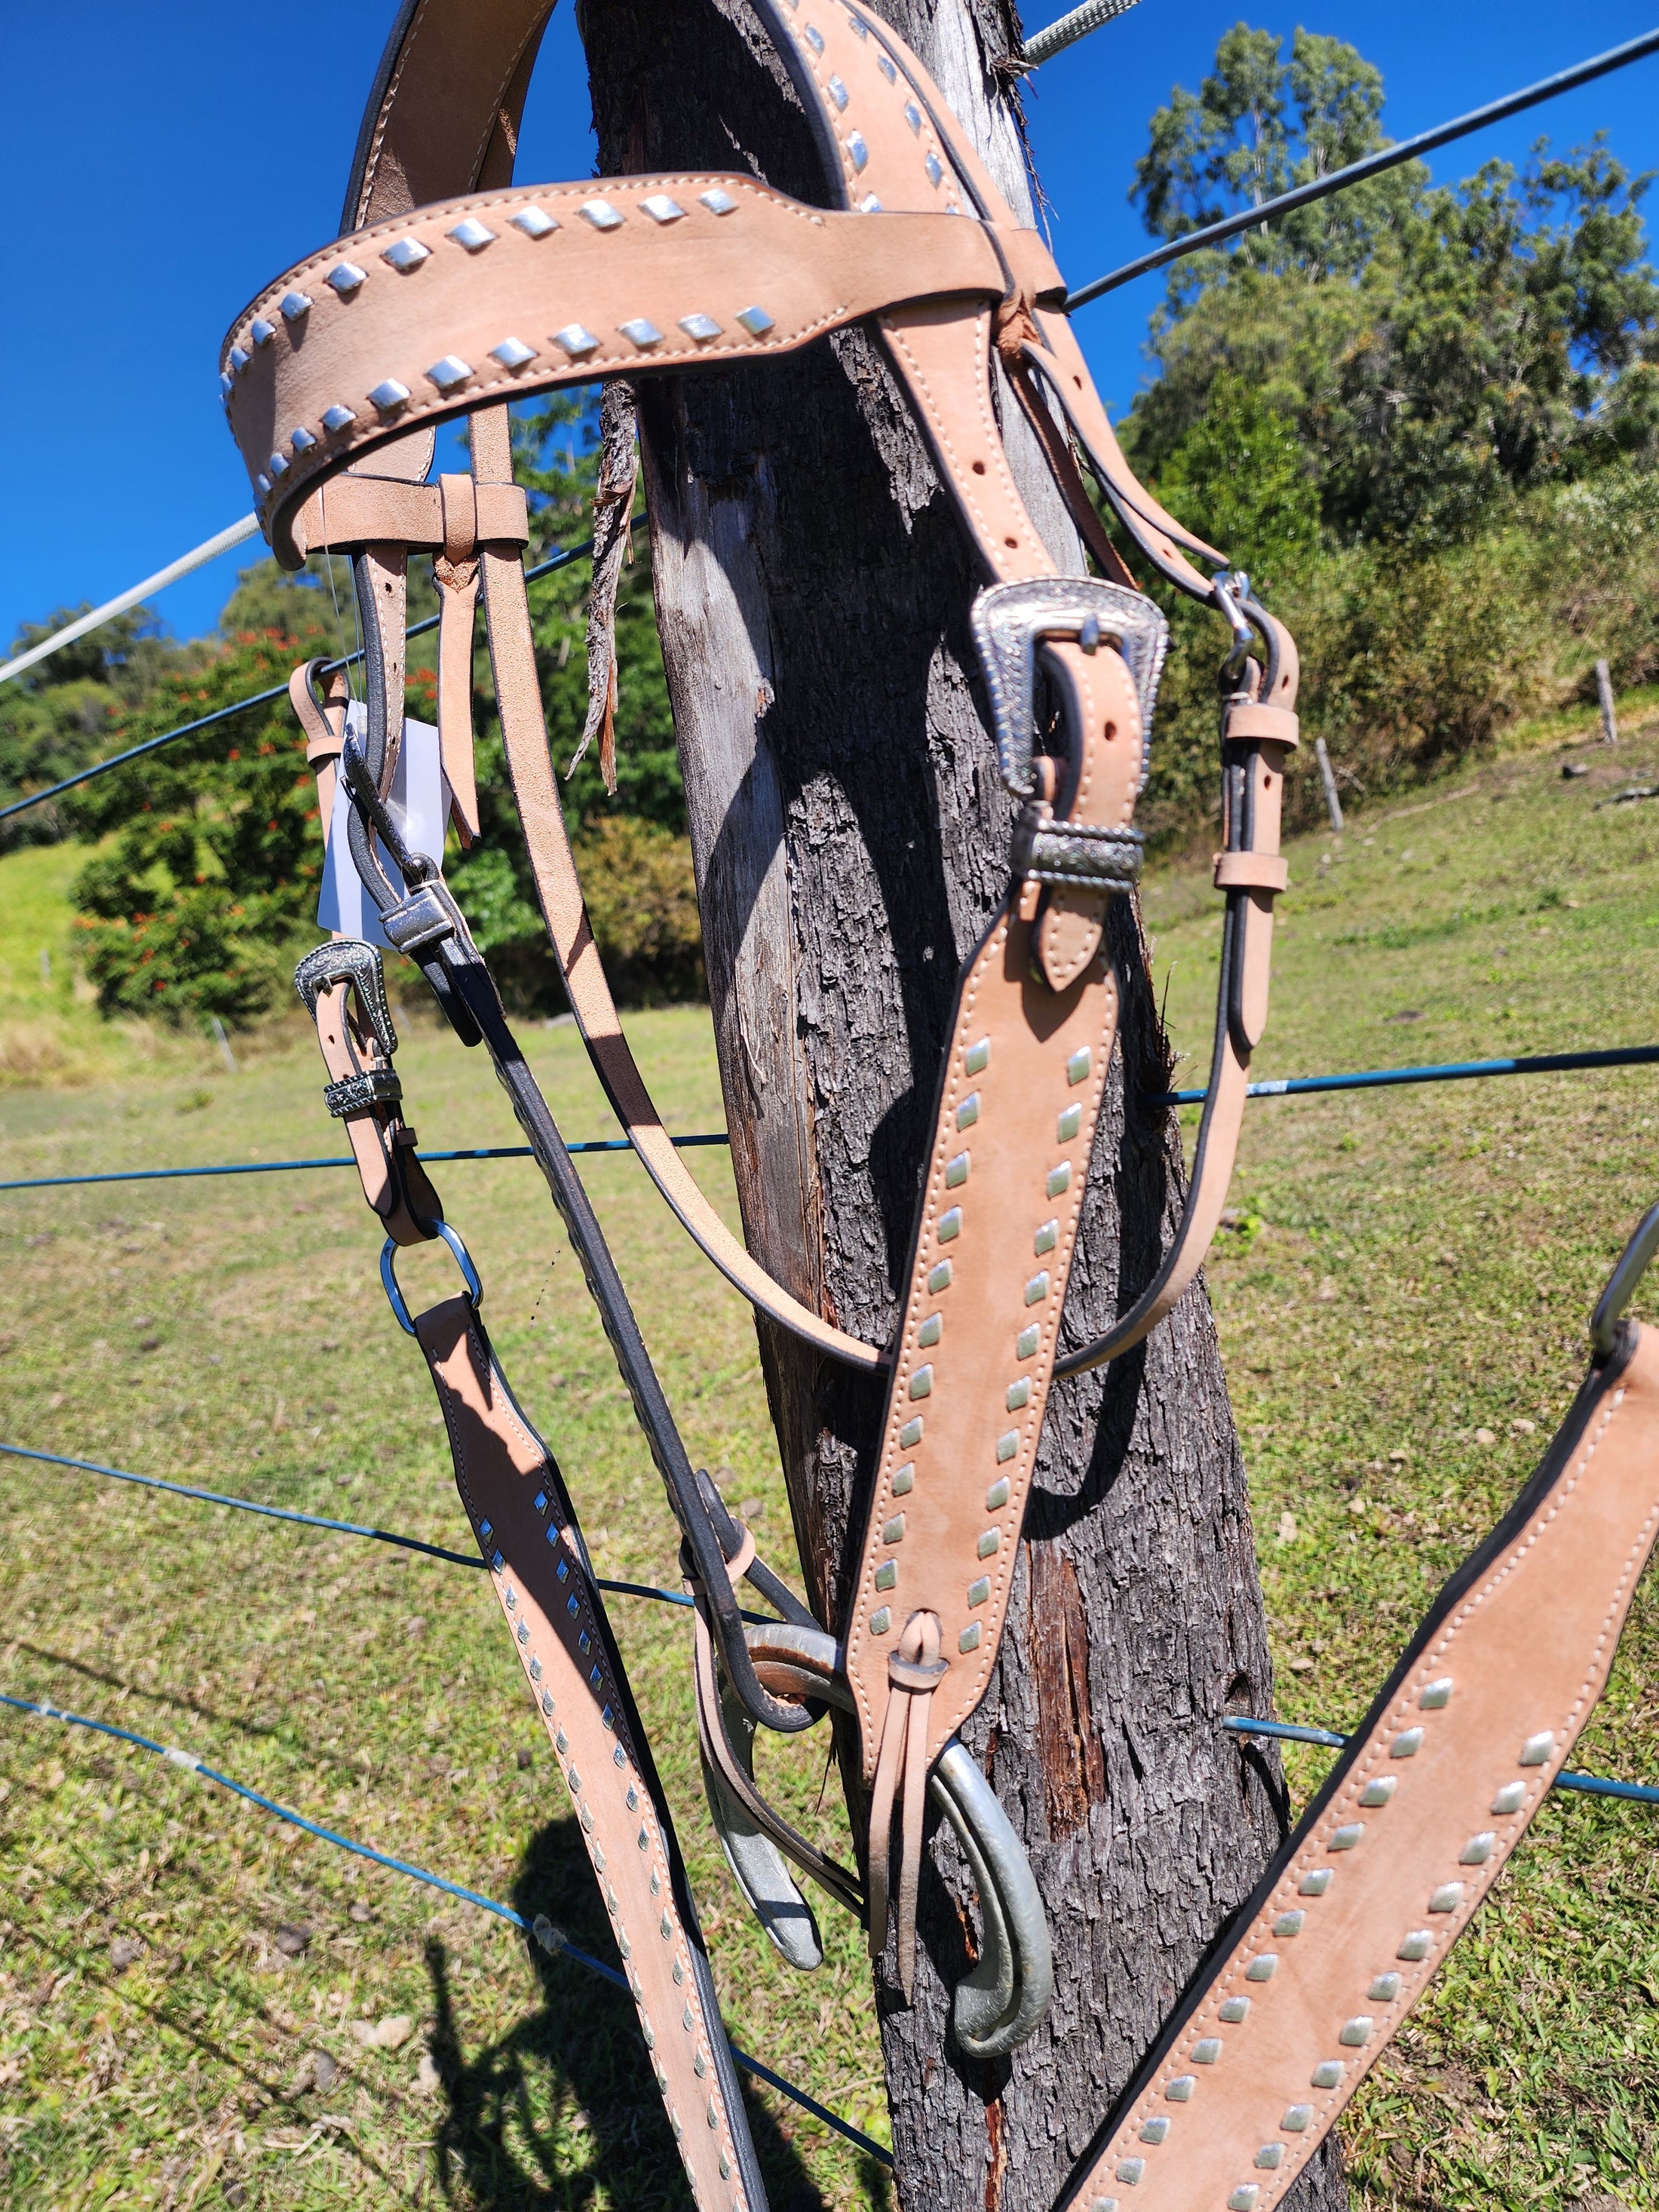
[1062,1327,1659,2212]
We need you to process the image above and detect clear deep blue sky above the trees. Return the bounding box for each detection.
[0,0,1659,646]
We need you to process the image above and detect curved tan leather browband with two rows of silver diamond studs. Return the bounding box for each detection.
[223,175,1044,566]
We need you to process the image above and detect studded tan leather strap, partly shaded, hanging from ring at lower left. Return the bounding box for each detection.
[416,1299,765,2212]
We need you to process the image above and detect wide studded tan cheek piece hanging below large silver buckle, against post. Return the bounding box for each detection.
[847,911,1117,1783]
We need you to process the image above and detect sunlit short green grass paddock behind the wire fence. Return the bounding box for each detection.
[0,716,1659,2212]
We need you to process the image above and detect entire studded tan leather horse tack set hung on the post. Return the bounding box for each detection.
[236,0,1659,2212]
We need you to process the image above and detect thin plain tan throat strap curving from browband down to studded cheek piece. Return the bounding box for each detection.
[471,407,882,1367]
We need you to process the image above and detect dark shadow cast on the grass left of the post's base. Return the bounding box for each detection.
[427,1818,836,2212]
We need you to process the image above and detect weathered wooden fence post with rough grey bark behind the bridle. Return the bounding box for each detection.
[581,0,1345,2212]
